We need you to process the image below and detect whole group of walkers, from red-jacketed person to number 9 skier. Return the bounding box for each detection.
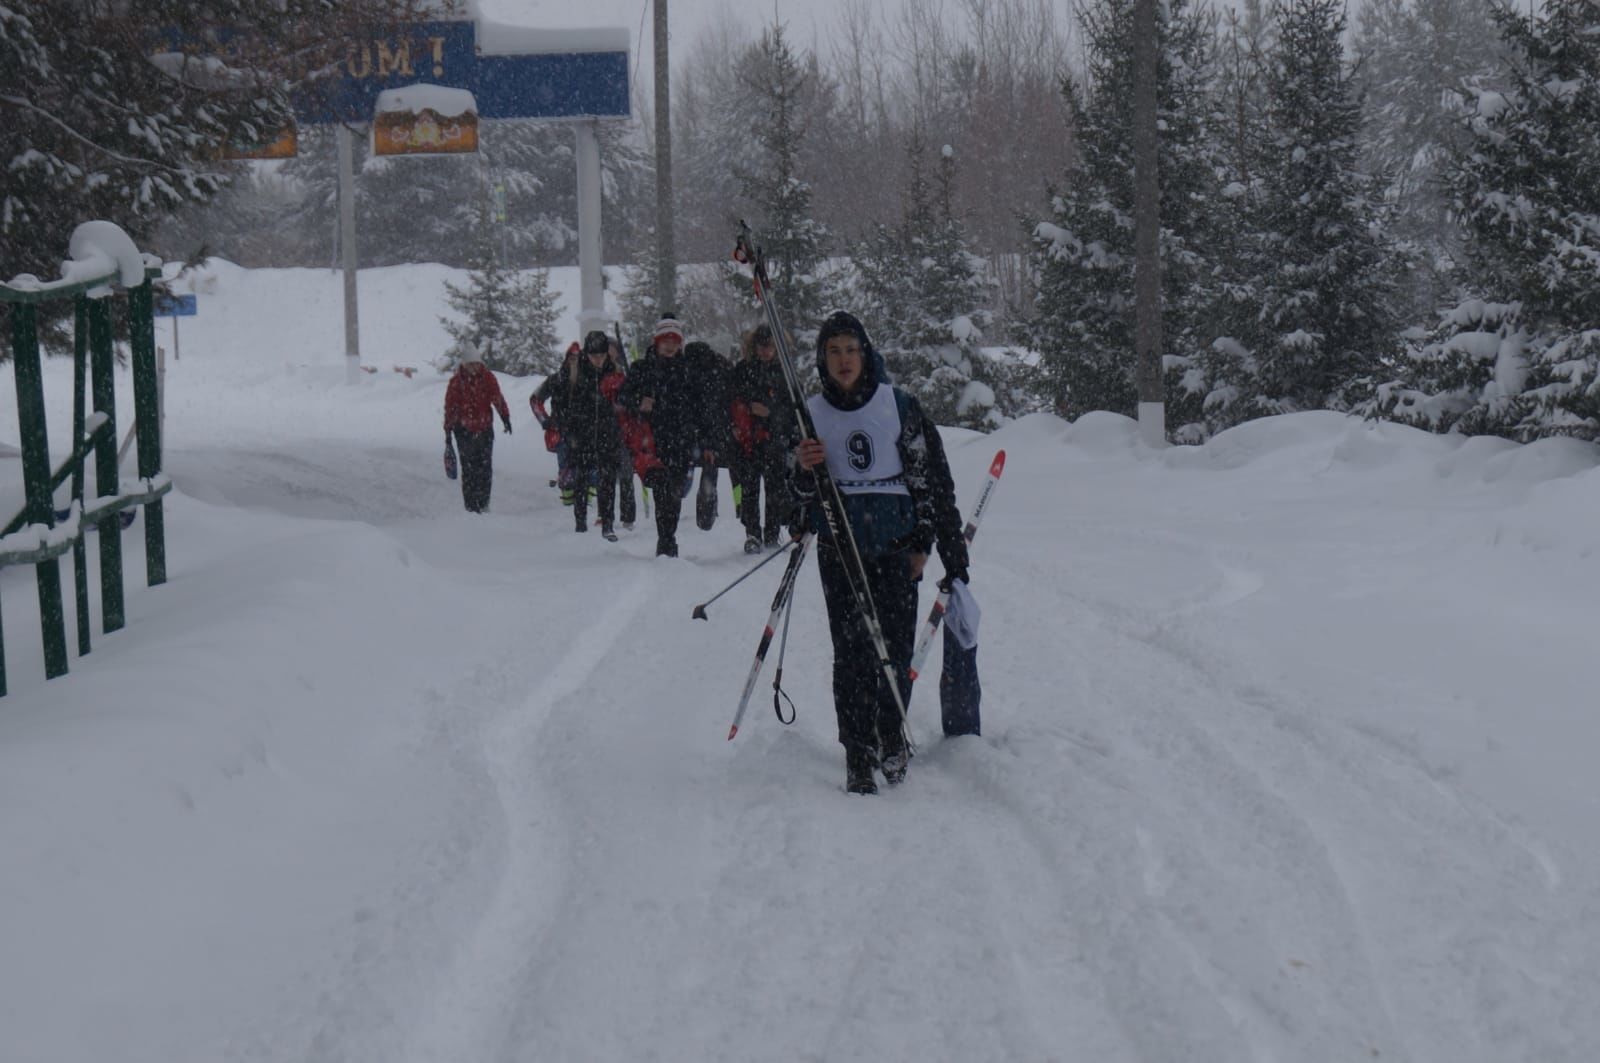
[445,312,968,794]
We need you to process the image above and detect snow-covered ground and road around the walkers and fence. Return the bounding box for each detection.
[0,264,1600,1063]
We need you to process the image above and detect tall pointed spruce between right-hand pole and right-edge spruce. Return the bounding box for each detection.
[1208,0,1398,427]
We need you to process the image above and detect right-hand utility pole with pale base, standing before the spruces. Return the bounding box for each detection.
[1133,0,1166,447]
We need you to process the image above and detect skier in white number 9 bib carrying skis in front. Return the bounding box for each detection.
[790,311,968,794]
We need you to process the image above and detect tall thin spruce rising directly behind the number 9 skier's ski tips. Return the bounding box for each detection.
[725,22,837,333]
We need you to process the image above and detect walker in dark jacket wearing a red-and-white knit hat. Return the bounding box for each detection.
[621,314,717,557]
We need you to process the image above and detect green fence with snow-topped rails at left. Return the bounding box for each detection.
[0,249,173,696]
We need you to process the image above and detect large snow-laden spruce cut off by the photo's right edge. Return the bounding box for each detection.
[1384,0,1600,440]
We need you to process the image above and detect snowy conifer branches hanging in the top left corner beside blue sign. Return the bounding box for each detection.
[0,0,438,275]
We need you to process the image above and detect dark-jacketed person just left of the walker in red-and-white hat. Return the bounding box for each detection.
[552,330,622,543]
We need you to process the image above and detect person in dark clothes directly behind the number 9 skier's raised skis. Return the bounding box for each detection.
[731,325,794,554]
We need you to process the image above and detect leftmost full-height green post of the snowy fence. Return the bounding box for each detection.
[11,303,71,679]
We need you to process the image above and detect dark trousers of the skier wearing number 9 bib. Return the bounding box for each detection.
[816,543,917,751]
